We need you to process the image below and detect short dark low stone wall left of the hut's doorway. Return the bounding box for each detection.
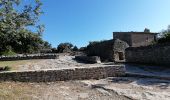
[75,56,101,63]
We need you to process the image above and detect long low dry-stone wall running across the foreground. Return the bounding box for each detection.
[0,66,125,82]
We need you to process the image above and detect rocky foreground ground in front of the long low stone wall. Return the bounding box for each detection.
[0,77,170,100]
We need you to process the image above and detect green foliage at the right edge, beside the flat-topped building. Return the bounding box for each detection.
[158,25,170,43]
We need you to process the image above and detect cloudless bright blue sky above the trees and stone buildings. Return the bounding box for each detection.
[37,0,170,47]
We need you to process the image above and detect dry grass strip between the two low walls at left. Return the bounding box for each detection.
[0,60,41,70]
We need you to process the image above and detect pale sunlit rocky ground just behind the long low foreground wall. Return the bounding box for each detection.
[17,56,111,71]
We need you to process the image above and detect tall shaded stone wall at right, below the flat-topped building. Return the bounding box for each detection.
[125,44,170,65]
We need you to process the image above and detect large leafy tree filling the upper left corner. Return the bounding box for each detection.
[0,0,44,53]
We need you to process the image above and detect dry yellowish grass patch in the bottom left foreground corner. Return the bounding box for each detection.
[0,82,41,100]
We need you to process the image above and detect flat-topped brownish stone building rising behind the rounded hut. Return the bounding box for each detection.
[113,31,158,47]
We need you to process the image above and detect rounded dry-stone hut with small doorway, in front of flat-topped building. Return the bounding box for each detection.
[87,39,129,62]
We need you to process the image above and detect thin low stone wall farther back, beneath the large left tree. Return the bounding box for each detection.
[0,54,59,61]
